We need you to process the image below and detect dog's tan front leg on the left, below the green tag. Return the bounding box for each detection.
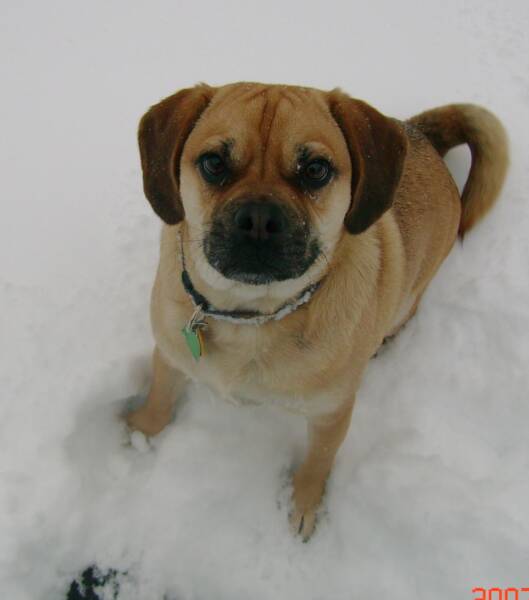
[127,348,185,436]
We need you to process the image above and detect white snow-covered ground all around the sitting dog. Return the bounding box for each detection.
[0,0,529,600]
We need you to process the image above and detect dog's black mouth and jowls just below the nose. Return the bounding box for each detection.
[203,203,321,285]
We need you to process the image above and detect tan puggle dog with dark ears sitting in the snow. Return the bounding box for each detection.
[127,83,508,540]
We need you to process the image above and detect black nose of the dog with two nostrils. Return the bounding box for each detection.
[233,201,287,240]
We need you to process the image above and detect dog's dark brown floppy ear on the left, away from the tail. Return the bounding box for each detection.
[138,84,218,225]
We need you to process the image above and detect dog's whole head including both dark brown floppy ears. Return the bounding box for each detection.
[139,83,406,285]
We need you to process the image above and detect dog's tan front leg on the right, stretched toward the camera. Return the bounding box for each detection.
[290,397,354,541]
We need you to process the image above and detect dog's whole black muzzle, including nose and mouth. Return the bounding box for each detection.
[204,197,320,285]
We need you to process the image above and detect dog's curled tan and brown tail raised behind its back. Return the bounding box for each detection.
[409,104,509,237]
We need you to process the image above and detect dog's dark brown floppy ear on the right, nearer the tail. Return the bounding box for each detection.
[329,90,407,233]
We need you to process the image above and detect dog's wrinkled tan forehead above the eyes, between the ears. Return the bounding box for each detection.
[186,84,349,167]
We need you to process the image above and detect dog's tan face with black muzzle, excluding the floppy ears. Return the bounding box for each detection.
[180,85,351,285]
